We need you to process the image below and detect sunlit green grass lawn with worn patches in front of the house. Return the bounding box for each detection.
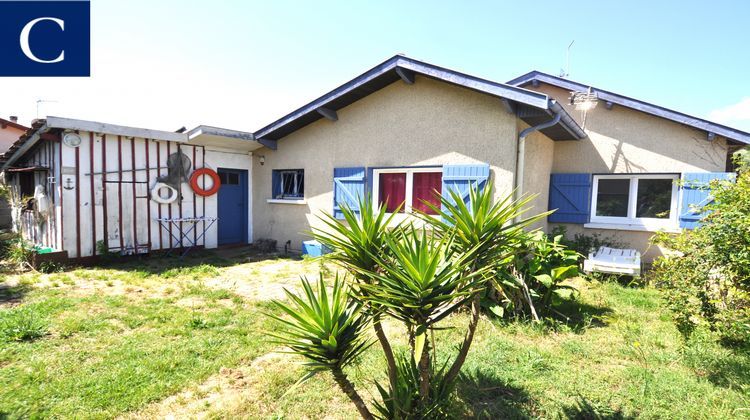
[0,251,750,418]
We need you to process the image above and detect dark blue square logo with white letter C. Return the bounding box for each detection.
[0,0,91,77]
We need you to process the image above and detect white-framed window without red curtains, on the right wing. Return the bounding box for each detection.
[590,174,680,230]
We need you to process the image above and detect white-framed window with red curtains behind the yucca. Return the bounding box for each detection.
[372,167,443,218]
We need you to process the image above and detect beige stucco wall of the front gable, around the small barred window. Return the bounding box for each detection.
[253,76,517,250]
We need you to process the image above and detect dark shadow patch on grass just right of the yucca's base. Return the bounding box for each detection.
[456,370,536,419]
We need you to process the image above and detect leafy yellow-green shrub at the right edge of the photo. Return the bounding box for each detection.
[652,150,750,345]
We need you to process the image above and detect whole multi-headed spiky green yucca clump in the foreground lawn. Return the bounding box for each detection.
[270,180,546,418]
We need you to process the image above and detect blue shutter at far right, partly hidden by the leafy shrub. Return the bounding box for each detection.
[680,172,735,229]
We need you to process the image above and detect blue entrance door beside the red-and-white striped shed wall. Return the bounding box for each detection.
[216,168,248,245]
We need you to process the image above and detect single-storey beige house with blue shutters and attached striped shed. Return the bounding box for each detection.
[0,56,750,260]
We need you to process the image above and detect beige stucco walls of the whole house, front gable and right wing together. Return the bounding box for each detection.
[252,76,727,261]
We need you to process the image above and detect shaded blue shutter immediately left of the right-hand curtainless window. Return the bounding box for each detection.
[547,174,591,224]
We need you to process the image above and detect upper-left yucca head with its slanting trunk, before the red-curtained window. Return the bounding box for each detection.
[310,196,402,387]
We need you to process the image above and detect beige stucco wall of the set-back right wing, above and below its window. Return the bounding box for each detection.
[527,84,727,261]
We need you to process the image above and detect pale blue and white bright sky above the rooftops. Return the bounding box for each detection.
[0,0,750,131]
